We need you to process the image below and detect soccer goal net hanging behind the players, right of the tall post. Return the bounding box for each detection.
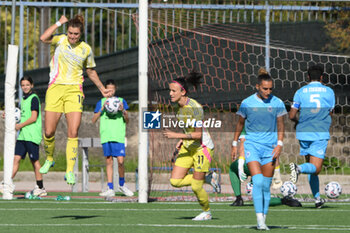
[136,3,350,200]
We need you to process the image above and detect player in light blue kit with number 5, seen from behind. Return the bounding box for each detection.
[289,65,335,208]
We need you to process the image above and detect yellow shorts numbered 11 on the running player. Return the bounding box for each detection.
[175,146,213,172]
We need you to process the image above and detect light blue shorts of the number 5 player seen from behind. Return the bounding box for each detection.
[299,140,328,159]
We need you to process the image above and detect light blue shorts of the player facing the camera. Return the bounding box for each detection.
[244,140,273,166]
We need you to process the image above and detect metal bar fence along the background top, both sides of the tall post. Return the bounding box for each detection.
[0,0,348,73]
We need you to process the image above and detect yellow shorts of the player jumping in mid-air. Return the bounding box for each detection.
[45,84,84,113]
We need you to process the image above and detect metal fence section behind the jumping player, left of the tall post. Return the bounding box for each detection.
[0,1,138,70]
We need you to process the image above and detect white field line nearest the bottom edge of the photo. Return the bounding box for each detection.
[0,223,350,231]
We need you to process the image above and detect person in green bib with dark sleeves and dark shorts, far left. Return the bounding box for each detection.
[1,76,47,196]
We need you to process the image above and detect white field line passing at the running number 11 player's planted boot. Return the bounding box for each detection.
[0,208,350,213]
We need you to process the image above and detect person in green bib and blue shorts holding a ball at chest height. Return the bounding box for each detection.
[92,79,134,197]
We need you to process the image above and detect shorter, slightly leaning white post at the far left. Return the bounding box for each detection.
[2,45,18,200]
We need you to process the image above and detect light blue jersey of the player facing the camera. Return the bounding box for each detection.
[237,94,287,146]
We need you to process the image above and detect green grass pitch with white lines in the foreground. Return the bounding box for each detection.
[0,193,350,233]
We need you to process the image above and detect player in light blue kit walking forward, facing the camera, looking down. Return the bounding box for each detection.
[231,69,287,230]
